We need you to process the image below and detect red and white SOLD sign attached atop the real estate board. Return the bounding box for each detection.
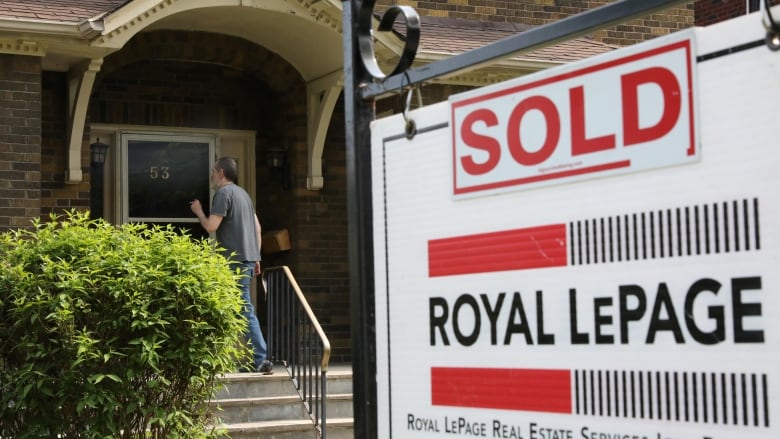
[450,31,699,196]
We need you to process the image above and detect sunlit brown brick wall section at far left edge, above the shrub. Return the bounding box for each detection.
[0,55,41,231]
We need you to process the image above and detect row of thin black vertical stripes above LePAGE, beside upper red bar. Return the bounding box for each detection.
[569,198,761,265]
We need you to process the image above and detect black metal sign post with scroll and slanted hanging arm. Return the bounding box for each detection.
[343,0,690,439]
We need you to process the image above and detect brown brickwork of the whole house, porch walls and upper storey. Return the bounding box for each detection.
[0,0,777,361]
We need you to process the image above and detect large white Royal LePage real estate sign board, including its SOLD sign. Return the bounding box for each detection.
[372,9,780,439]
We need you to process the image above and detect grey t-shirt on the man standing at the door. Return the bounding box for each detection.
[211,184,260,261]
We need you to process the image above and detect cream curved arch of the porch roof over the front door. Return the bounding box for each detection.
[91,0,342,82]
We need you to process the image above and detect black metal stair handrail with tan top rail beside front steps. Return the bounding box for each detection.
[263,265,330,439]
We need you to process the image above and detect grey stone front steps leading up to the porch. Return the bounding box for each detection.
[210,365,354,439]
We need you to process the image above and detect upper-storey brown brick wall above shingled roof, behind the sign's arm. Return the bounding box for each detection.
[376,0,694,46]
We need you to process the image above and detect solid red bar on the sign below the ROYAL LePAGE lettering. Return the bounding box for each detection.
[431,367,572,413]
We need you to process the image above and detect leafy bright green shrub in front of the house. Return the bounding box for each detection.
[0,212,248,439]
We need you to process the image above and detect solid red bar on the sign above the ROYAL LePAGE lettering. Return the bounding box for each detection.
[428,224,567,277]
